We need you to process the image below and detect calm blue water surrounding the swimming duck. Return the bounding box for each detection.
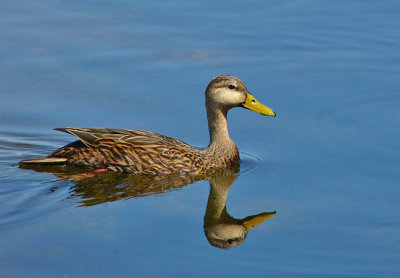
[0,0,400,277]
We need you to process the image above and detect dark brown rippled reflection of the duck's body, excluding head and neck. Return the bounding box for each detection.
[20,164,200,206]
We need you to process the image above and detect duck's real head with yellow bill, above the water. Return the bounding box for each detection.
[206,75,276,117]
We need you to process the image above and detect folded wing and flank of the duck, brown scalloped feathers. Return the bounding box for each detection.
[51,128,201,173]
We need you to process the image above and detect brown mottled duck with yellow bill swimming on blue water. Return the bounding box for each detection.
[21,75,276,175]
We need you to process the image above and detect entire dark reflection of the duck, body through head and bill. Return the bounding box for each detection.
[20,164,275,249]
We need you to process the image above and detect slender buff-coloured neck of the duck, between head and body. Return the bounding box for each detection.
[206,106,239,164]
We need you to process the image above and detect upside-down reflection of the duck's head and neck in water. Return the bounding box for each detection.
[204,167,275,249]
